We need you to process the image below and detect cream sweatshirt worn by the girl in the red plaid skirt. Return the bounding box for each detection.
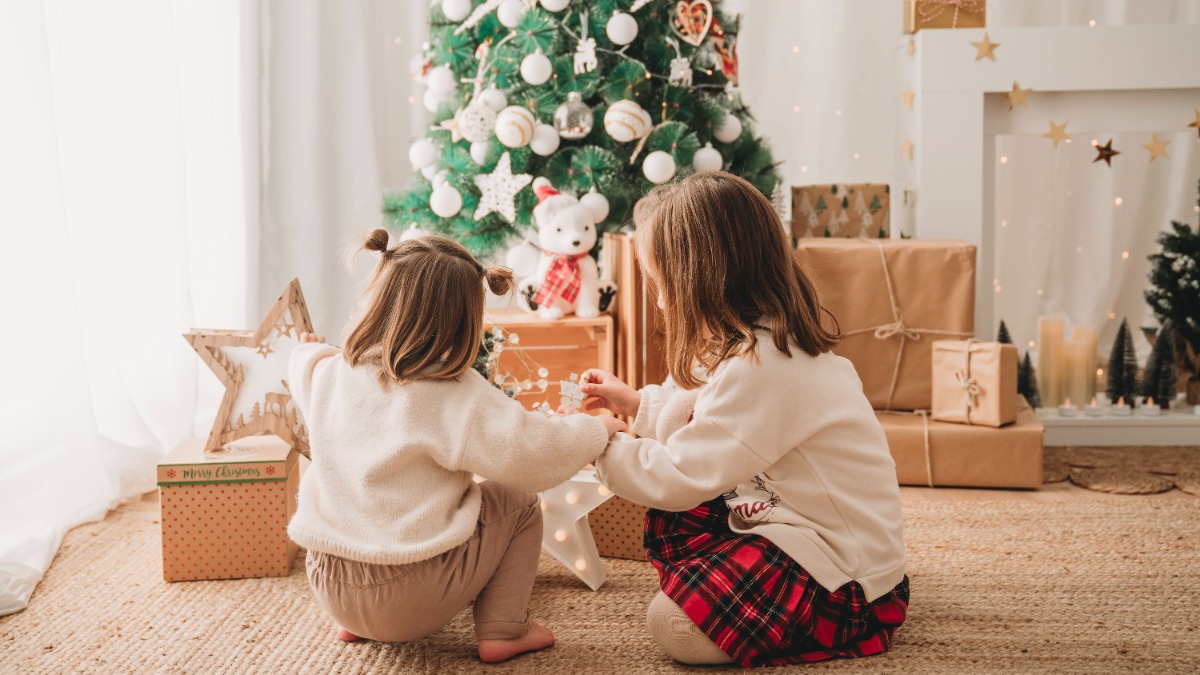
[596,331,905,601]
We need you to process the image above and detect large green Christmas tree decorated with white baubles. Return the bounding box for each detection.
[384,0,780,256]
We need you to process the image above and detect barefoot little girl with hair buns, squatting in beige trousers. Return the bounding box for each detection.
[288,229,625,662]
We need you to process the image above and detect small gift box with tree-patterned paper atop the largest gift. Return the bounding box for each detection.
[792,183,892,239]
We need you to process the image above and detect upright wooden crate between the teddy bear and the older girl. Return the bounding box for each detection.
[601,232,667,389]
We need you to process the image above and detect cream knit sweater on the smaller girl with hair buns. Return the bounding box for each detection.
[288,344,608,565]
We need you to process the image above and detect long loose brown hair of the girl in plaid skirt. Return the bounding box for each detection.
[634,172,840,389]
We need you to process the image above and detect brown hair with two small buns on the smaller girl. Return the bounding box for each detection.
[343,228,512,384]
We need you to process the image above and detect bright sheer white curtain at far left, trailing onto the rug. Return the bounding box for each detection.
[0,0,252,614]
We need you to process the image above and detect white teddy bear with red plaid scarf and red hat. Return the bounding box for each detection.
[506,178,617,319]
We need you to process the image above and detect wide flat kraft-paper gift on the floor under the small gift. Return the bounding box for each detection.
[876,400,1045,489]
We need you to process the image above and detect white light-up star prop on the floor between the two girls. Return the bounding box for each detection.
[541,471,612,591]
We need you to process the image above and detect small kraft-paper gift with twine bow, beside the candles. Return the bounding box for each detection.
[930,340,1018,426]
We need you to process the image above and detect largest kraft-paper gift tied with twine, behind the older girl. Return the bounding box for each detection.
[796,239,976,410]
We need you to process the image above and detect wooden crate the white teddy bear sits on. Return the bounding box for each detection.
[484,309,616,408]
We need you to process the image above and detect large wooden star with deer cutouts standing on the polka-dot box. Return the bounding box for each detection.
[184,279,312,455]
